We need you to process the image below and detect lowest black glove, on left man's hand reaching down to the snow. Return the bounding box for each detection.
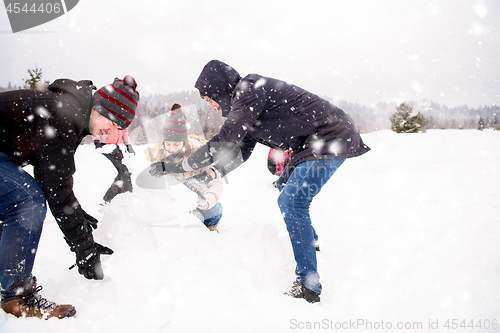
[69,243,114,280]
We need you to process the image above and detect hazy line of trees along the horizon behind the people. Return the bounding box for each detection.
[0,67,500,143]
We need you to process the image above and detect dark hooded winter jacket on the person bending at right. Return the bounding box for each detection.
[186,60,370,180]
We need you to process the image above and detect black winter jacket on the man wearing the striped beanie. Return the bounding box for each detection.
[0,79,95,250]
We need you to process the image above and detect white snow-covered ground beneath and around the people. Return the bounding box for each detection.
[0,130,500,333]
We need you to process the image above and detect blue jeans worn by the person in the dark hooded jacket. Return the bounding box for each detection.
[276,159,345,294]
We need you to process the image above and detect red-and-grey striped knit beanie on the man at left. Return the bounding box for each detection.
[93,75,139,129]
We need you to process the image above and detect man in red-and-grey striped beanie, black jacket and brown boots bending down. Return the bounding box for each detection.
[0,76,139,318]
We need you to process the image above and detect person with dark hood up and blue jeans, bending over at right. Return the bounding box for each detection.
[150,60,369,303]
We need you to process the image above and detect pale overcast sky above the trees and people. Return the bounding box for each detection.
[0,0,500,106]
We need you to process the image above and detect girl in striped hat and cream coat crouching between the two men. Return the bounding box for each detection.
[144,104,223,231]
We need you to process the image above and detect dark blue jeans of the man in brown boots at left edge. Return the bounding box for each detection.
[0,152,47,301]
